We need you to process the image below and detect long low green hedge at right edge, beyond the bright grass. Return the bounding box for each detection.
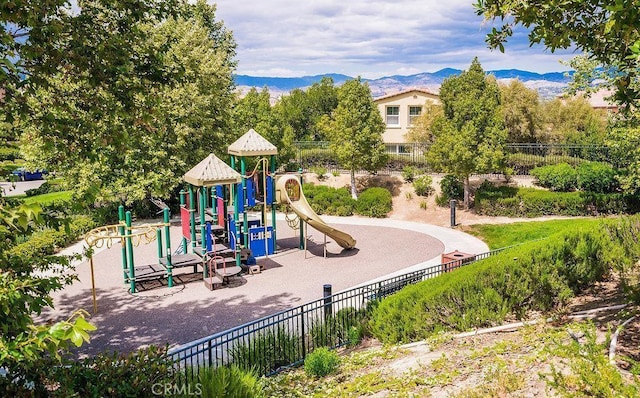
[475,184,640,217]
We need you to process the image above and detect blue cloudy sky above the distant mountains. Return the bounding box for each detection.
[210,0,576,78]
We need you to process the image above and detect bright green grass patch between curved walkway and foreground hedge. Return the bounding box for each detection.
[465,218,600,250]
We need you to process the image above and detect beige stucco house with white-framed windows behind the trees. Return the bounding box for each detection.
[373,88,440,151]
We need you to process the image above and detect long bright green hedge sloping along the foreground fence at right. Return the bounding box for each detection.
[370,222,633,343]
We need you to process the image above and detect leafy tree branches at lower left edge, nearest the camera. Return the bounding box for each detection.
[0,202,95,396]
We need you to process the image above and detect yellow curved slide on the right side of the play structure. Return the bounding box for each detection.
[276,175,356,249]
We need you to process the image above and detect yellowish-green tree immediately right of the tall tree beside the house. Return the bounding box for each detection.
[499,80,540,142]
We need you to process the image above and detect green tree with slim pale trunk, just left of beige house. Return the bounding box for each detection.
[320,78,387,199]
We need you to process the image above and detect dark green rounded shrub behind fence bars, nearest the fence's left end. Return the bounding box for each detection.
[231,327,302,375]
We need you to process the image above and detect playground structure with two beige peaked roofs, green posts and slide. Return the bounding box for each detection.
[85,129,356,304]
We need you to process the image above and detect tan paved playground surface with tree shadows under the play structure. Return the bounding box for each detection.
[42,217,487,355]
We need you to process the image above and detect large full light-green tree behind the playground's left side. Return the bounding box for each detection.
[23,0,235,203]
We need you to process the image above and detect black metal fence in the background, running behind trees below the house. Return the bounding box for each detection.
[294,141,615,175]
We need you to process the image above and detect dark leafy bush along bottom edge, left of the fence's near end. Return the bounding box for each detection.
[50,346,174,397]
